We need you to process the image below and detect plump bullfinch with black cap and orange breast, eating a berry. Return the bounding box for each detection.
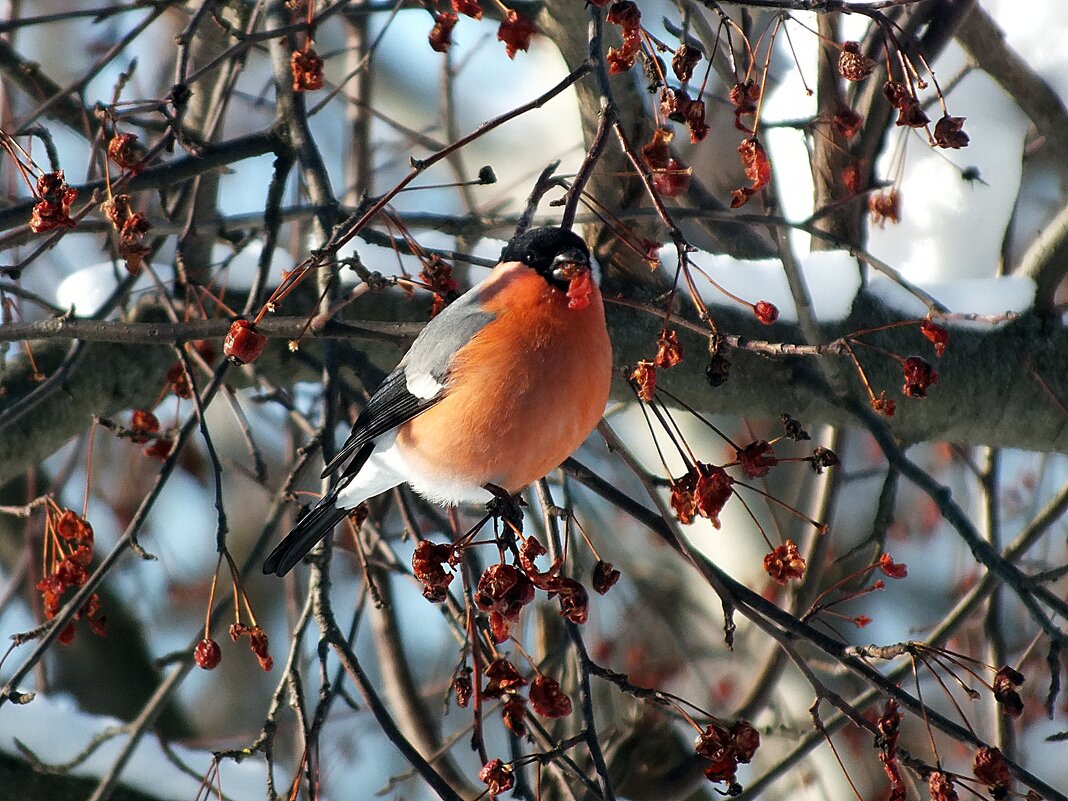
[263,226,612,576]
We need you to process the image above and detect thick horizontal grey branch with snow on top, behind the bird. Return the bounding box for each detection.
[0,286,1068,493]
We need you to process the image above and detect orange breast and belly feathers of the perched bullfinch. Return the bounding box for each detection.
[397,264,612,492]
